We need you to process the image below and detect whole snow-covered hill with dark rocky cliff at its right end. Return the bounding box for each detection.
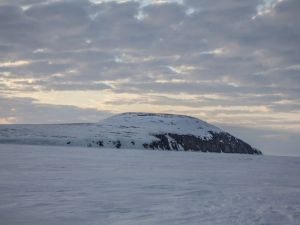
[0,113,261,154]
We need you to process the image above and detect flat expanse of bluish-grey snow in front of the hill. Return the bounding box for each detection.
[0,145,300,225]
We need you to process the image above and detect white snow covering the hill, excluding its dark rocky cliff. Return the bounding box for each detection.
[0,113,222,149]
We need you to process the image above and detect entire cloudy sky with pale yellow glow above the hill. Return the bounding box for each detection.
[0,0,300,156]
